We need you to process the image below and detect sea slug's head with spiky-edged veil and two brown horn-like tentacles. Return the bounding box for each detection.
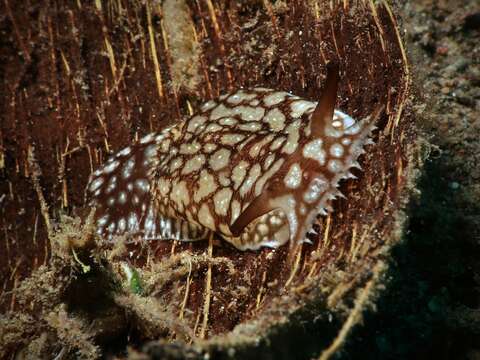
[231,66,383,249]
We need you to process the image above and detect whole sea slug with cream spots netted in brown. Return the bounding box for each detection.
[87,66,376,250]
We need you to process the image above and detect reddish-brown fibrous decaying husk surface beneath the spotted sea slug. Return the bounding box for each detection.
[0,0,420,358]
